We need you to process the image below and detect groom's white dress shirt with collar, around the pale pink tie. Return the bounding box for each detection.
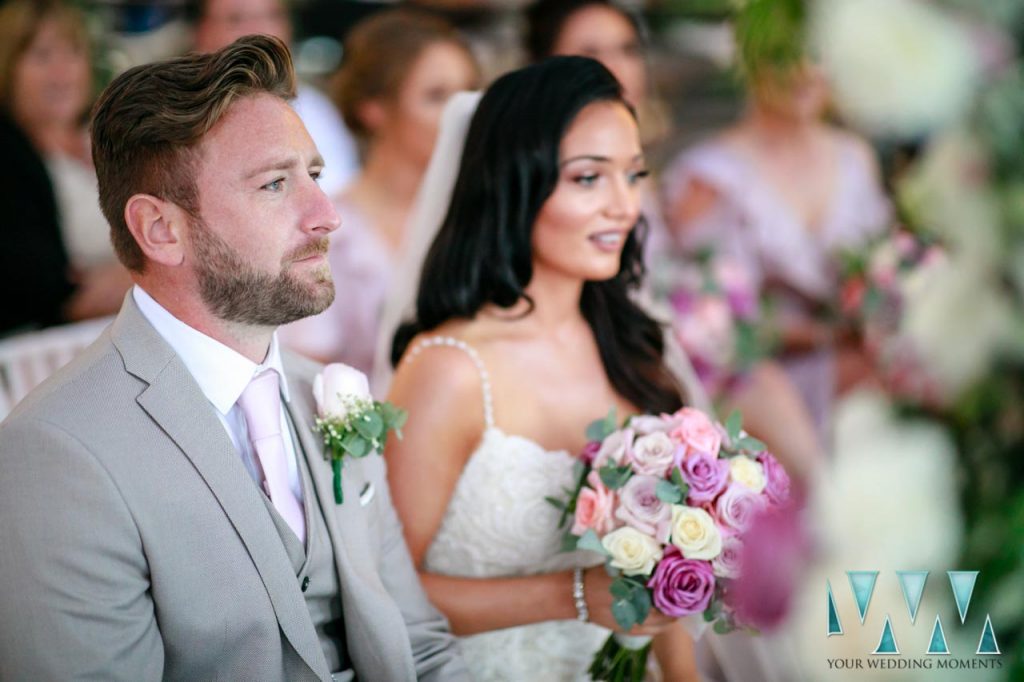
[132,285,302,502]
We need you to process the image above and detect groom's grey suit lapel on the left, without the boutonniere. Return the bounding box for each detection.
[112,293,330,679]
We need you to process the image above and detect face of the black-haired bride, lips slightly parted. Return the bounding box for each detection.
[532,101,647,281]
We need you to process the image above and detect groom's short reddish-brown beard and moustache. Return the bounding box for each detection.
[190,218,334,327]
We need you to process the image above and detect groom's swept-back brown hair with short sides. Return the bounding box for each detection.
[92,36,295,271]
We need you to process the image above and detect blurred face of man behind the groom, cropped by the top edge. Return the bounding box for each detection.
[196,0,292,52]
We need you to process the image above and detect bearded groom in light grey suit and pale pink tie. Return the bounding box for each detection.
[0,37,467,682]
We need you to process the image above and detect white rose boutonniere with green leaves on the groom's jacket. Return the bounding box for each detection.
[313,363,409,505]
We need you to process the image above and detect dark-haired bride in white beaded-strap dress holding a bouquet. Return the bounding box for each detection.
[385,57,697,680]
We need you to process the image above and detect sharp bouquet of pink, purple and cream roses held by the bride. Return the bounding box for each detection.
[548,408,790,681]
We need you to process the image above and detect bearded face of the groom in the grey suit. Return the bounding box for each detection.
[186,94,341,327]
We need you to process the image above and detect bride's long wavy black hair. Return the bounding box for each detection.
[391,56,682,413]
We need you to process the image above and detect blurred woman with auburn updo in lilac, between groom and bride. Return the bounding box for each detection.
[282,9,478,382]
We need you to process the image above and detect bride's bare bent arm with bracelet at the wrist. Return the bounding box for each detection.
[384,347,670,635]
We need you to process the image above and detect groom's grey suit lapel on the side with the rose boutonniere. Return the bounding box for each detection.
[285,358,416,680]
